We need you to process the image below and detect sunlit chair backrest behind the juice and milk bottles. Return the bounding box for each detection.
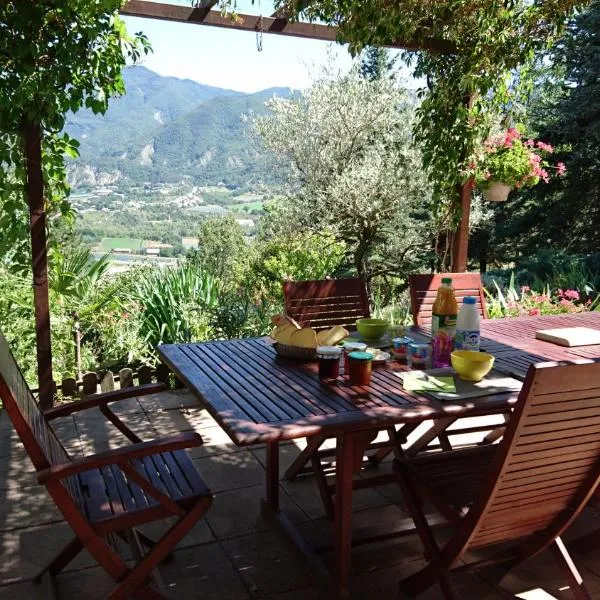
[408,273,488,326]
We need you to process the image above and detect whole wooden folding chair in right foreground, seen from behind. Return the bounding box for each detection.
[394,361,600,600]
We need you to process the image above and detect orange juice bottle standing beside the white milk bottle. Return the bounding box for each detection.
[431,277,458,368]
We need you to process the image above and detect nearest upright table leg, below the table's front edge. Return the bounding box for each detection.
[333,433,356,599]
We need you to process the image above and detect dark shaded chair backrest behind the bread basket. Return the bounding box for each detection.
[283,279,370,330]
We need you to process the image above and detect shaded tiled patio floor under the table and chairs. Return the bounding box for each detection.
[0,391,600,600]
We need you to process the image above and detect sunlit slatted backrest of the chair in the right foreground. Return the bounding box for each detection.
[454,360,600,564]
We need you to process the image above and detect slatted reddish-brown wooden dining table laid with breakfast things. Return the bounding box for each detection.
[158,313,600,598]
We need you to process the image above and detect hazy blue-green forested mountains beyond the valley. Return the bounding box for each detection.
[66,66,290,188]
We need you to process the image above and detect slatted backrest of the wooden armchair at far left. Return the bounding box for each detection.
[0,331,70,471]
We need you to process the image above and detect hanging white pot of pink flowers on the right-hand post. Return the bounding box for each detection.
[469,127,566,202]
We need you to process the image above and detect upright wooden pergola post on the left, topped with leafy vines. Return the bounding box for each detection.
[23,123,54,409]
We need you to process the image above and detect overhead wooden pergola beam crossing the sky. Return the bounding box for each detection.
[120,0,453,54]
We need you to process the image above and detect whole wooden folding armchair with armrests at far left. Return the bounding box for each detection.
[0,332,212,599]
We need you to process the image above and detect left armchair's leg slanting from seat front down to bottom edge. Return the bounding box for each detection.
[109,496,212,600]
